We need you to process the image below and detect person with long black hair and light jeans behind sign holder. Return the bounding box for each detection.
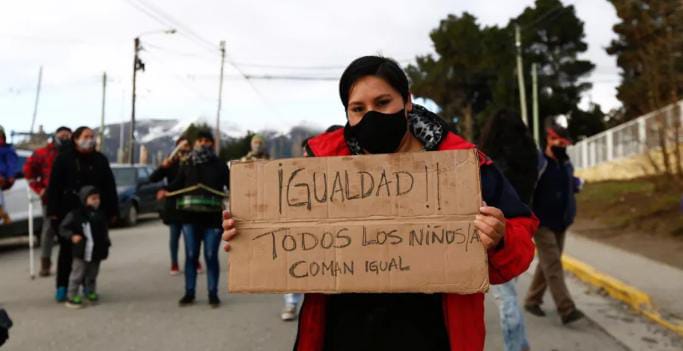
[479,109,538,351]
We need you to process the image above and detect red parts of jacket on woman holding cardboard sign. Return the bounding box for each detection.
[296,129,538,351]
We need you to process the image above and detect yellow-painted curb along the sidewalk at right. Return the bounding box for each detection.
[562,255,683,336]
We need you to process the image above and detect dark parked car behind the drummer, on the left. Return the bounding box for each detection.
[111,164,164,226]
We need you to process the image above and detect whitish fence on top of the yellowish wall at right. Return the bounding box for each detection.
[567,100,683,169]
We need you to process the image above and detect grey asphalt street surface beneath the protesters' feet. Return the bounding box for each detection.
[0,221,668,351]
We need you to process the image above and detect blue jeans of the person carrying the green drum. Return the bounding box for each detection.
[183,224,221,296]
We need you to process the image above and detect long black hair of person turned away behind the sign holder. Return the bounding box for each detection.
[479,109,538,205]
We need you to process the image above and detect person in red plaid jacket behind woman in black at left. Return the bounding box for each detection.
[24,126,71,277]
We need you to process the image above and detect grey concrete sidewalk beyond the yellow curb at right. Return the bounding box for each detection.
[565,233,683,319]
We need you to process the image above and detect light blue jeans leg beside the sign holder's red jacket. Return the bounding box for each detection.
[491,279,529,351]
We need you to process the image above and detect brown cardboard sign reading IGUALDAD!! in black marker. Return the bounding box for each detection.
[228,150,488,294]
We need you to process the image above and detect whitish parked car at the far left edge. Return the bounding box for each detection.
[0,149,43,242]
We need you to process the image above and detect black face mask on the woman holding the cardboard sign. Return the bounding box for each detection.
[345,109,408,154]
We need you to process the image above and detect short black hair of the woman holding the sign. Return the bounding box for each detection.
[339,56,410,109]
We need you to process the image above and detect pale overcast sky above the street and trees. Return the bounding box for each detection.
[0,0,619,140]
